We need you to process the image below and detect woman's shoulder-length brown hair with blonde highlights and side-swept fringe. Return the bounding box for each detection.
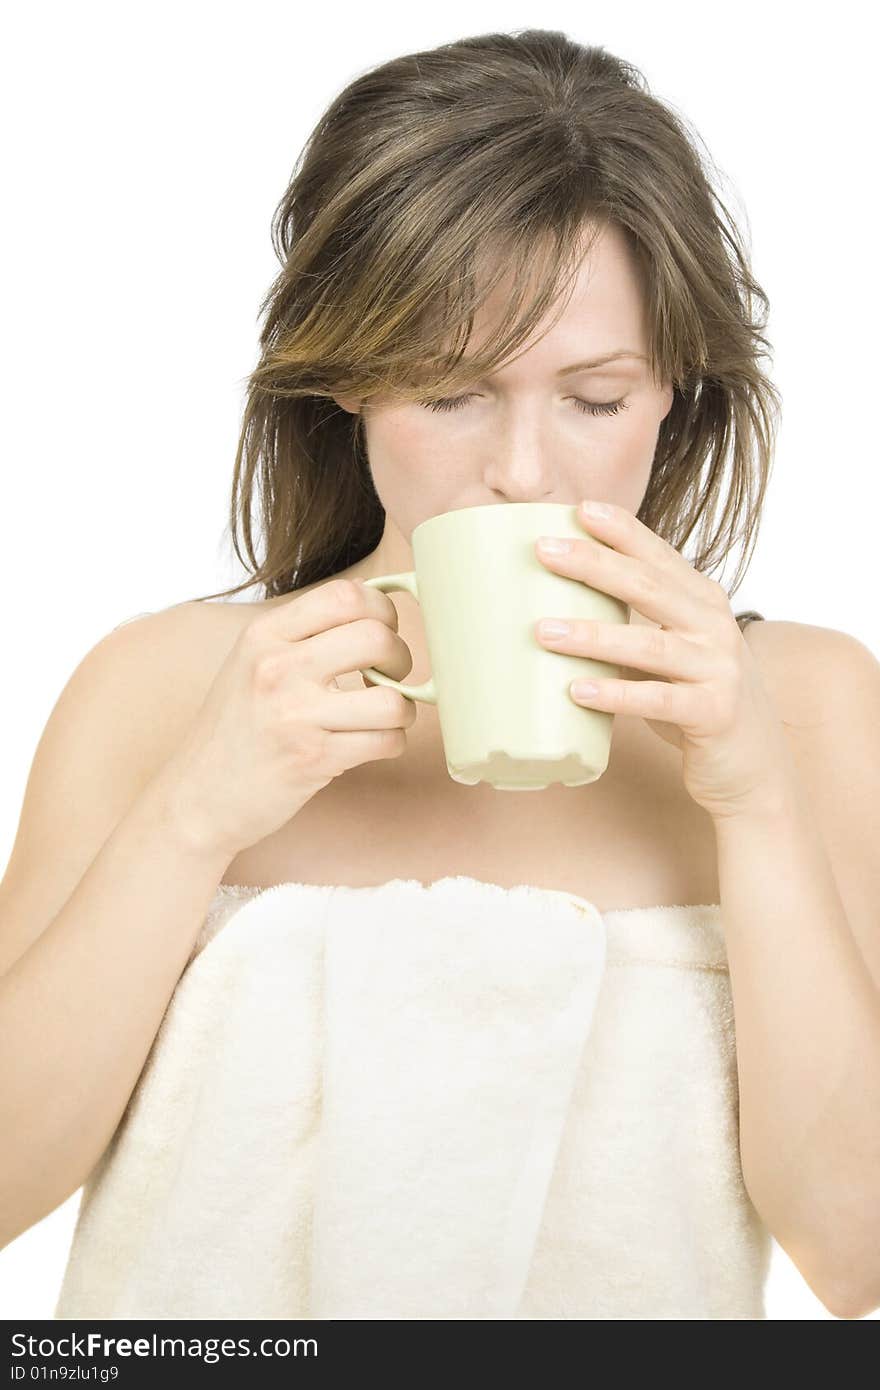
[189,29,780,602]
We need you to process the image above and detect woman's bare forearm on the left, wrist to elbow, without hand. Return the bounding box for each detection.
[0,776,228,1245]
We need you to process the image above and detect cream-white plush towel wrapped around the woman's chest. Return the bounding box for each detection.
[56,877,770,1319]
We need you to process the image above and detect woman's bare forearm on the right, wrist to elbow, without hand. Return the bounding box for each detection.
[716,769,880,1301]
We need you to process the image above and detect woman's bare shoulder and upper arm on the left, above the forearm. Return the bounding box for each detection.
[0,603,258,973]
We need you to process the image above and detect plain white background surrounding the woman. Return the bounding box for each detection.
[0,0,880,1319]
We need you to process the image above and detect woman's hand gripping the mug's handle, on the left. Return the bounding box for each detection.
[163,580,416,860]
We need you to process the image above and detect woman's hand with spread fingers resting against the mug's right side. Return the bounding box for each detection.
[535,503,790,817]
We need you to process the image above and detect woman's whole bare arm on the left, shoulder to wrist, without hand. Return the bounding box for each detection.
[0,610,229,1244]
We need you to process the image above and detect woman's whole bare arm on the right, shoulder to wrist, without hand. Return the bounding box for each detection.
[715,624,880,1318]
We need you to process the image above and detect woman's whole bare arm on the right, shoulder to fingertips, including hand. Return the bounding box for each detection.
[535,500,880,1316]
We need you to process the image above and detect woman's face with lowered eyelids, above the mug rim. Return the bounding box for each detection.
[329,227,673,577]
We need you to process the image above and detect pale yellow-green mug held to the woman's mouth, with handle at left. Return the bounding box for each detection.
[361,502,630,791]
